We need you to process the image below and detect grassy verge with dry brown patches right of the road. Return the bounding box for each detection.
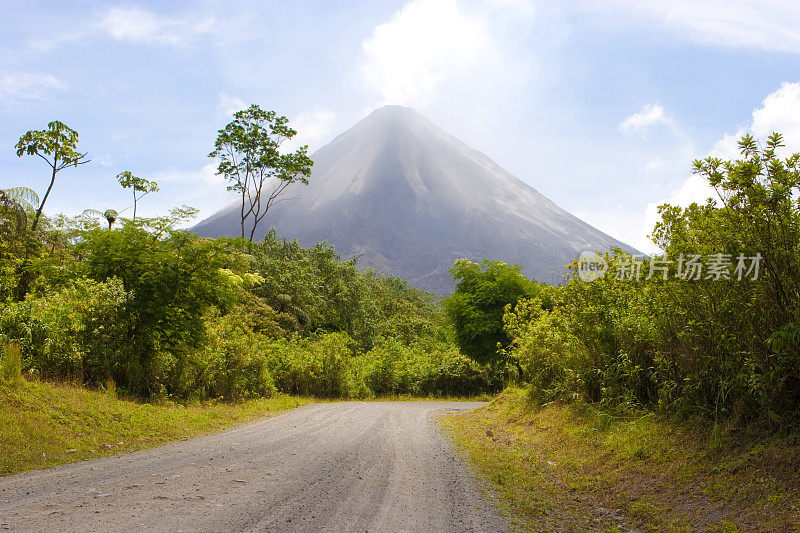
[442,389,800,531]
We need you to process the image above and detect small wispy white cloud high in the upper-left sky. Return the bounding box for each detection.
[99,7,214,45]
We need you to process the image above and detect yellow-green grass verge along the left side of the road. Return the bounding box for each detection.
[0,380,314,476]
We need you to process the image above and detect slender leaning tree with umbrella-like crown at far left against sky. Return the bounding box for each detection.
[15,120,89,231]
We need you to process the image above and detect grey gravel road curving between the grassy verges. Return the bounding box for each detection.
[0,402,507,532]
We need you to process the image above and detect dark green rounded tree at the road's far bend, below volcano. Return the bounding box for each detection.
[444,259,539,362]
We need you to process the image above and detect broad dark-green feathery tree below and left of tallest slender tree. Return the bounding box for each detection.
[77,221,243,394]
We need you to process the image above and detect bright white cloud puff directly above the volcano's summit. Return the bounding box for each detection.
[363,0,489,104]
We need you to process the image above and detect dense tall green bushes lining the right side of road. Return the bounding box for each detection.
[499,134,800,429]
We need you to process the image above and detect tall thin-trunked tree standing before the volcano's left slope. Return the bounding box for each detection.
[208,105,314,242]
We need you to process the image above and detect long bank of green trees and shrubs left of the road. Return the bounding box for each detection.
[0,209,502,399]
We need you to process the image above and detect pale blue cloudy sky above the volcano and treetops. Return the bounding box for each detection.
[0,0,800,251]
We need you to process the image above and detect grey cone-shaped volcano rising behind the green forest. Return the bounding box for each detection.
[194,106,636,294]
